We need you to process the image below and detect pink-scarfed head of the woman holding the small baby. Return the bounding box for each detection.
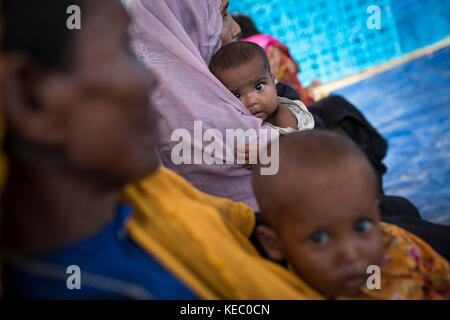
[127,0,236,69]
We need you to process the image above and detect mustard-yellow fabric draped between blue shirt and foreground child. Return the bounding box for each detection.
[124,168,322,299]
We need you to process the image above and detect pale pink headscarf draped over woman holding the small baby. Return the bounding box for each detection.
[127,0,276,211]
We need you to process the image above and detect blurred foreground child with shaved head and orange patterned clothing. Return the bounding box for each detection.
[252,130,450,299]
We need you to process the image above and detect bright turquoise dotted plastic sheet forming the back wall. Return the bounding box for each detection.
[229,0,450,85]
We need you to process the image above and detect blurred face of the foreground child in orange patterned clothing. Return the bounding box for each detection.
[278,168,384,298]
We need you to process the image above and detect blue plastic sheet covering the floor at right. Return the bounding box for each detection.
[334,47,450,225]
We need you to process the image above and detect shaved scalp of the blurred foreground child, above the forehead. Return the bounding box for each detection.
[252,130,378,227]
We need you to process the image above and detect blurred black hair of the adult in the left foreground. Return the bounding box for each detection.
[1,0,84,69]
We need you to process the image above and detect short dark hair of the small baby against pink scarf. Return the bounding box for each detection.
[209,41,272,75]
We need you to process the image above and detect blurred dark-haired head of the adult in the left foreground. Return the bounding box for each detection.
[2,0,158,184]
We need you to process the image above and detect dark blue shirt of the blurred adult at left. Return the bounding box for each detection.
[3,205,197,300]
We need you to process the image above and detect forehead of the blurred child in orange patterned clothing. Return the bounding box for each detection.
[278,170,378,228]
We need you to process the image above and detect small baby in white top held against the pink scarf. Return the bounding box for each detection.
[209,41,314,134]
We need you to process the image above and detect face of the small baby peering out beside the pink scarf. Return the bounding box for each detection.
[217,58,278,121]
